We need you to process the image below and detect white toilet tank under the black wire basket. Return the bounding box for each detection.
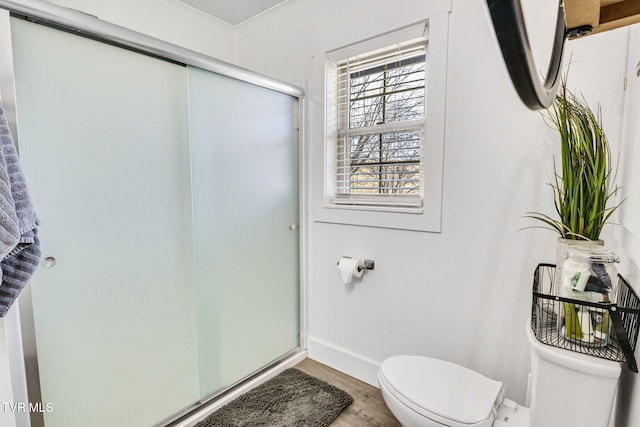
[527,322,621,427]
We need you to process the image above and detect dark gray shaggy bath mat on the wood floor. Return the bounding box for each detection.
[195,368,353,427]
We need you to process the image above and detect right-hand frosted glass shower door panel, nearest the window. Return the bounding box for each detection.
[189,68,300,398]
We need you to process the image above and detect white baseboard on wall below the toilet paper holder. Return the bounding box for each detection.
[307,337,380,388]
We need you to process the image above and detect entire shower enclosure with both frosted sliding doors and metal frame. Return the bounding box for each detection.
[0,2,302,427]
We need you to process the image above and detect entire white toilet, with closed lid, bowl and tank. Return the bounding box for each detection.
[378,323,621,427]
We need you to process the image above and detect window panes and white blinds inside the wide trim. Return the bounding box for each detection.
[333,38,427,207]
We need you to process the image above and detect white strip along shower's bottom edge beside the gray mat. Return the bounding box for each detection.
[168,351,307,427]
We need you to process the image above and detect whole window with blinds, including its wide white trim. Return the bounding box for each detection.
[322,15,450,232]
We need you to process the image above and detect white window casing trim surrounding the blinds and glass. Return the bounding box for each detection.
[316,12,449,232]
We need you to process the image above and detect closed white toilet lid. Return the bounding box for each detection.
[380,355,502,424]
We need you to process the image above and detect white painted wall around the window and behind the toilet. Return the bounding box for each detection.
[237,0,627,403]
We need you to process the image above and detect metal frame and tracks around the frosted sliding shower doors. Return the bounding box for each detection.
[0,0,307,427]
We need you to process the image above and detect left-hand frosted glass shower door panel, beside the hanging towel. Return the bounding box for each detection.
[12,19,200,427]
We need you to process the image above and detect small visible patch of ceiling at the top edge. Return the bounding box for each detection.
[180,0,289,25]
